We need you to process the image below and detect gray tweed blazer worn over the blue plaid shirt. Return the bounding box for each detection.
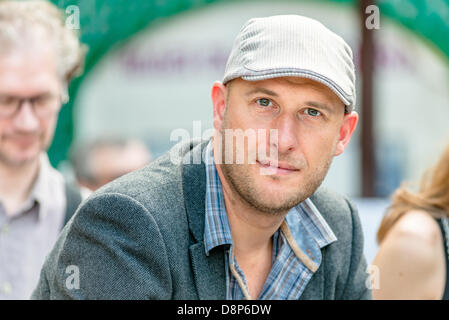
[32,141,371,300]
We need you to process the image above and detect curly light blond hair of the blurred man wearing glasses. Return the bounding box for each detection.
[0,0,86,84]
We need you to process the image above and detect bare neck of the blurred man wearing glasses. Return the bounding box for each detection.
[0,157,40,215]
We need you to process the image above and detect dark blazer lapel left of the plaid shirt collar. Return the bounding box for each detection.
[182,141,226,300]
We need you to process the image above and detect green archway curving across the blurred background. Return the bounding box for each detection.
[49,0,449,166]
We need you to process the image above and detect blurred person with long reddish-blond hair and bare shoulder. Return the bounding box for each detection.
[373,145,449,300]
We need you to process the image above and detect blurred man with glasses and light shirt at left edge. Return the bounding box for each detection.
[0,1,84,299]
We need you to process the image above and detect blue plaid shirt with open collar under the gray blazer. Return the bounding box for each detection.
[204,141,337,300]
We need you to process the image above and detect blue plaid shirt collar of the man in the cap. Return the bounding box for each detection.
[204,140,337,265]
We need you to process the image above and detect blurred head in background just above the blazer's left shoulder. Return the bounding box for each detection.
[71,139,151,191]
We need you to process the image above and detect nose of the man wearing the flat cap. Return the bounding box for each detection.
[274,114,298,154]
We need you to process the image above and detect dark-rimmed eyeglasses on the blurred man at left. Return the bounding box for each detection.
[0,93,62,118]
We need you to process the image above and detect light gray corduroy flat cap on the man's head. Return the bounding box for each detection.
[223,15,356,111]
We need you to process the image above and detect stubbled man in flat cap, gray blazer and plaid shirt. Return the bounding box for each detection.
[33,15,371,300]
